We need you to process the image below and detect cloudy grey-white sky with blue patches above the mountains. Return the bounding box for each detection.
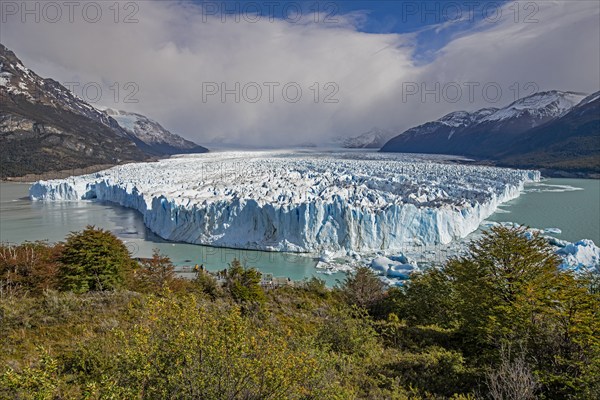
[0,0,600,147]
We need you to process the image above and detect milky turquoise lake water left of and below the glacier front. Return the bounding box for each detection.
[0,182,344,286]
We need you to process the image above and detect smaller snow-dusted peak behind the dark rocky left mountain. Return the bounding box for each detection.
[102,108,208,155]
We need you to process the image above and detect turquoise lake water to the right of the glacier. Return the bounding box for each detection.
[488,178,600,245]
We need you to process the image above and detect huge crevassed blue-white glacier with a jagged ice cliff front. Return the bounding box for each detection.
[30,151,540,253]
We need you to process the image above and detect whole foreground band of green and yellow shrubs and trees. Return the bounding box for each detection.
[0,227,600,400]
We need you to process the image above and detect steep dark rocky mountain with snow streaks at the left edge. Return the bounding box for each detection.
[0,44,206,179]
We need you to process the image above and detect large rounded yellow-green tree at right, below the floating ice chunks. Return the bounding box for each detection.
[444,227,560,352]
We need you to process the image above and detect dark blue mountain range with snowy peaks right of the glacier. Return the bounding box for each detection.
[381,90,600,177]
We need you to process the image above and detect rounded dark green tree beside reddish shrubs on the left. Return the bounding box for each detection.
[59,226,135,293]
